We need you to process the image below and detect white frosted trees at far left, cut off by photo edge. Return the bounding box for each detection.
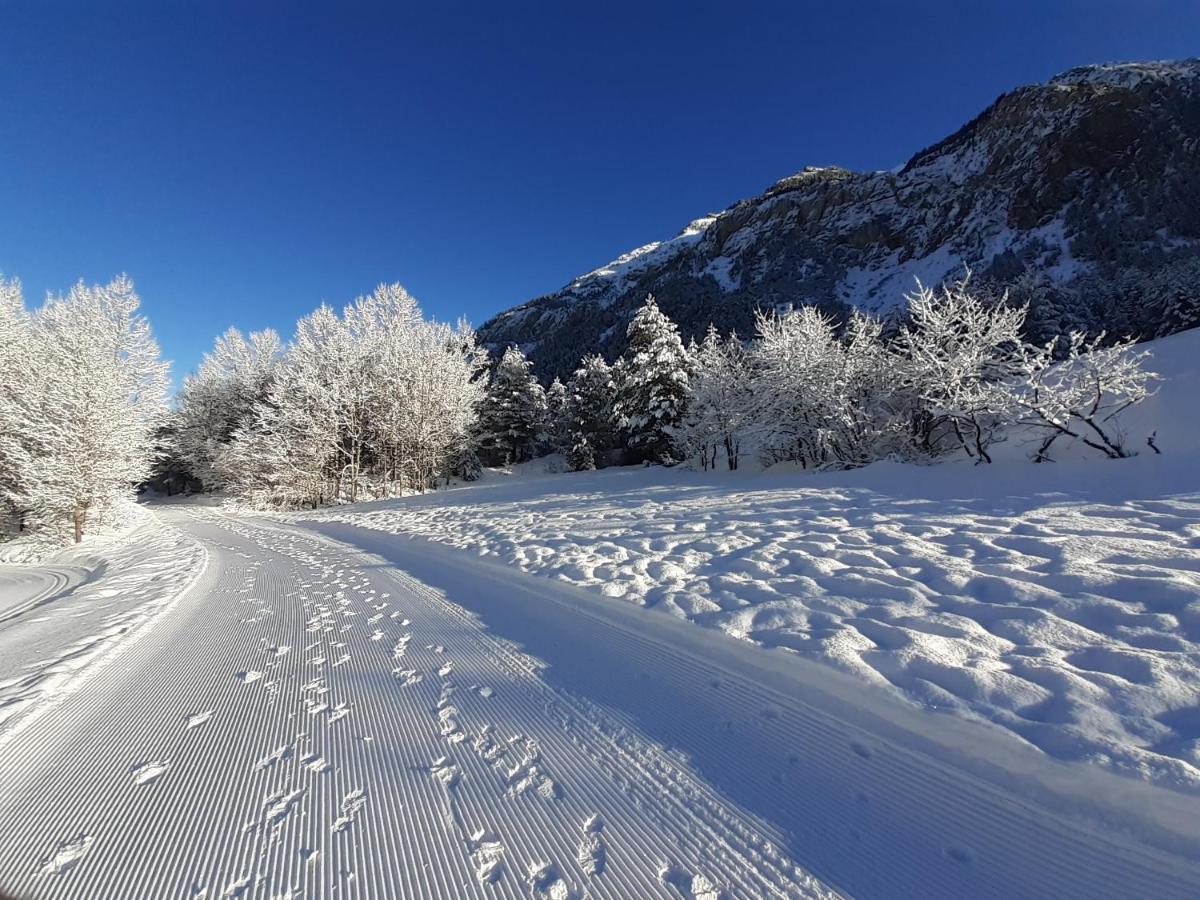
[0,276,168,541]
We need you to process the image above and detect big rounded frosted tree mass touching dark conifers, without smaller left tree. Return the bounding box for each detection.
[217,284,484,505]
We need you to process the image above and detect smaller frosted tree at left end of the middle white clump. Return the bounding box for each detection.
[170,328,282,490]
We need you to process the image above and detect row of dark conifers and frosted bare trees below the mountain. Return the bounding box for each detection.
[479,281,1154,480]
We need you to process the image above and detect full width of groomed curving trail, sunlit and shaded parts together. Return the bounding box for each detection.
[0,506,1200,900]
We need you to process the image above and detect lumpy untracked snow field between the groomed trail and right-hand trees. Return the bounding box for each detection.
[294,331,1200,791]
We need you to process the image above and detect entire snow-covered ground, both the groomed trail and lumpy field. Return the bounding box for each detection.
[0,331,1200,900]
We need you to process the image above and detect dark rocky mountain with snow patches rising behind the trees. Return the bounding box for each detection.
[479,59,1200,377]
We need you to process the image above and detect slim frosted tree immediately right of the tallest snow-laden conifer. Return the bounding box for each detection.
[672,325,754,472]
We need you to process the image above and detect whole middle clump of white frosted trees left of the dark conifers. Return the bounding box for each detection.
[168,284,487,506]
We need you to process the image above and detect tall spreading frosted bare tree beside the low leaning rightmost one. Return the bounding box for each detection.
[896,278,1026,462]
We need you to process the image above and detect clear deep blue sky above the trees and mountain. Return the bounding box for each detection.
[0,0,1200,378]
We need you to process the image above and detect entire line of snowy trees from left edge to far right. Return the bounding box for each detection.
[0,271,1154,540]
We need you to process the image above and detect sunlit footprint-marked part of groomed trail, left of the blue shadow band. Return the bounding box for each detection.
[0,509,830,900]
